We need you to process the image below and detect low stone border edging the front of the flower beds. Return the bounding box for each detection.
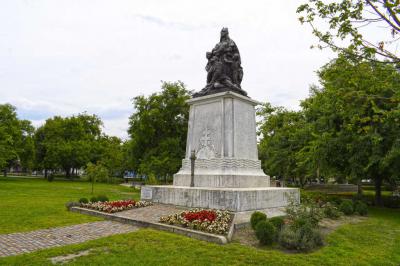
[70,207,230,244]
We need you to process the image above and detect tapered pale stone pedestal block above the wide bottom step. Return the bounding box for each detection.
[174,92,269,188]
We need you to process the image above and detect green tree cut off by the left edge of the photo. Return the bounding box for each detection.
[0,104,34,175]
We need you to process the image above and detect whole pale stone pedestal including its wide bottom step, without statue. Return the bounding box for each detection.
[141,91,299,212]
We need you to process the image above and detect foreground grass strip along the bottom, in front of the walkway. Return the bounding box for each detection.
[0,208,400,265]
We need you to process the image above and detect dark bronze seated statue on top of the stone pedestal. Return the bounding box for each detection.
[193,28,247,97]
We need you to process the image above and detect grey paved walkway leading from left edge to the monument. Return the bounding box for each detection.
[0,221,138,257]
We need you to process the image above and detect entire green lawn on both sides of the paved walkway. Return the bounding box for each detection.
[0,179,400,265]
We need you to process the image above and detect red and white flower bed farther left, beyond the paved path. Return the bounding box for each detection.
[81,200,152,213]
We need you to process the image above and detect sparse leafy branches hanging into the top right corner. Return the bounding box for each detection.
[297,0,400,64]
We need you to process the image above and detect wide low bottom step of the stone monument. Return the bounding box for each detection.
[141,186,300,212]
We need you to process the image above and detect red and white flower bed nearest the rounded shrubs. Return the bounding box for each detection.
[160,209,232,235]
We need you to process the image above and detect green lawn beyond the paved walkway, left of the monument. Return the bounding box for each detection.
[0,177,139,234]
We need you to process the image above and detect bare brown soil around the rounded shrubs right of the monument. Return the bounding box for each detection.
[232,216,368,248]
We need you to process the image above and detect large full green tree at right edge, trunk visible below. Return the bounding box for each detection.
[302,56,400,205]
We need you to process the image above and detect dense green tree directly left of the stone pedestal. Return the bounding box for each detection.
[128,82,190,179]
